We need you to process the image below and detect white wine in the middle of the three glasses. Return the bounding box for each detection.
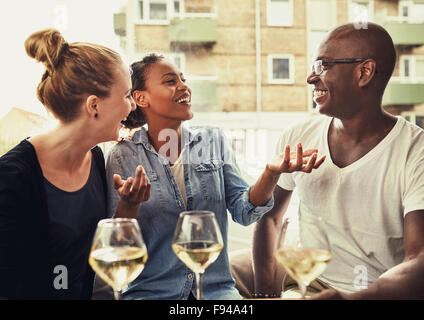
[172,241,223,273]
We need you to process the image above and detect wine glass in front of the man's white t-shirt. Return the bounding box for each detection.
[275,215,332,299]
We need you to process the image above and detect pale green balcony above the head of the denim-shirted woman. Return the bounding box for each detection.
[169,17,217,48]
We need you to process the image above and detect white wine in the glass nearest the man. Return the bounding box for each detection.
[275,248,332,286]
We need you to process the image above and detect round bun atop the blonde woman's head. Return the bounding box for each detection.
[25,28,68,73]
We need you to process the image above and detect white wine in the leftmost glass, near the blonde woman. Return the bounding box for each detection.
[88,247,147,290]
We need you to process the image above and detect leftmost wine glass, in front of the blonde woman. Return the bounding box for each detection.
[88,218,147,300]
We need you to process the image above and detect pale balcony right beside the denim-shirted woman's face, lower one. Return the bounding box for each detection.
[187,77,217,111]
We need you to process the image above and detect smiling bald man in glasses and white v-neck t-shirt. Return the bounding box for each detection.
[253,23,424,299]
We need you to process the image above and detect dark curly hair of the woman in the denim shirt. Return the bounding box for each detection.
[122,53,165,129]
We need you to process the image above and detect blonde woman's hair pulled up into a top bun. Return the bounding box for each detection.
[25,29,123,122]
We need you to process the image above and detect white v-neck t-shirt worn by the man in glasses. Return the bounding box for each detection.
[277,116,424,293]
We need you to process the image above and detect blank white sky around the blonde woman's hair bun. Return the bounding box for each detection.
[0,0,126,118]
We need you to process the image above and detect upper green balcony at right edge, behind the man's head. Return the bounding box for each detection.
[384,22,424,46]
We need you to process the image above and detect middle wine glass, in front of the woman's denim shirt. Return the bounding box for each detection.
[172,211,224,300]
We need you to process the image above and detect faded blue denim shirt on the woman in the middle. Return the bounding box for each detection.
[106,126,274,300]
